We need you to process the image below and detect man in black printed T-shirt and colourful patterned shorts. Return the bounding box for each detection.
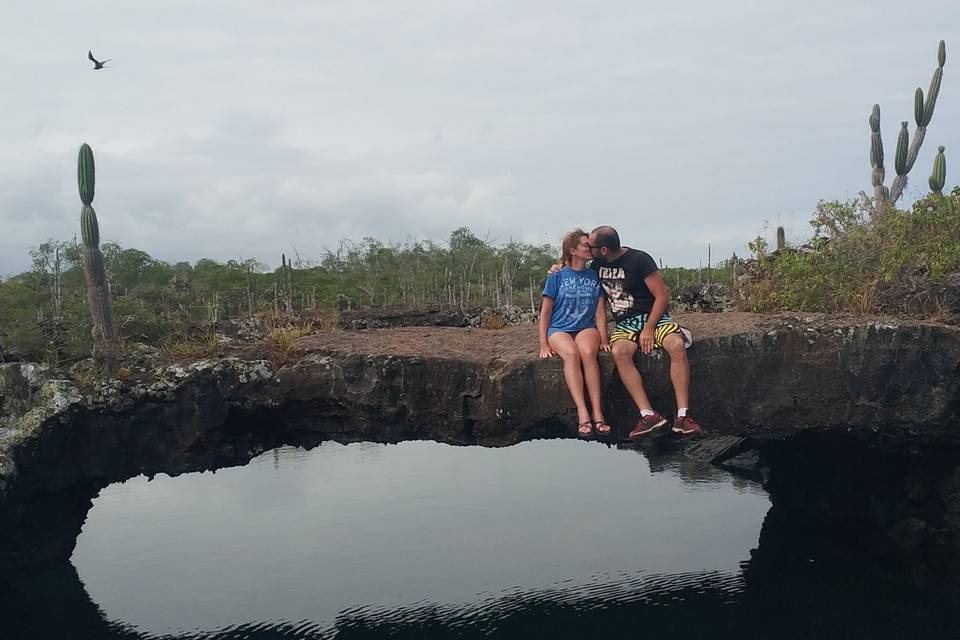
[590,226,702,440]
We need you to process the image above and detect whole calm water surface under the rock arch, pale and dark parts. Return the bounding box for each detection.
[8,440,954,639]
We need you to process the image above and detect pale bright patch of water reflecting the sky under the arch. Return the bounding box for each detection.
[73,440,769,633]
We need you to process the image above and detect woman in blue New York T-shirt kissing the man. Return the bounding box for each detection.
[540,229,610,438]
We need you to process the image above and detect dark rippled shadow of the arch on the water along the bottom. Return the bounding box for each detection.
[7,561,960,640]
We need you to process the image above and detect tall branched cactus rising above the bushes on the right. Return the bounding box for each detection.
[869,40,947,209]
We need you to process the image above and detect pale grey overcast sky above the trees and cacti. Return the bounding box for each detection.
[0,0,960,275]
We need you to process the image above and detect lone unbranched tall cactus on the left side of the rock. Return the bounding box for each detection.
[77,143,118,376]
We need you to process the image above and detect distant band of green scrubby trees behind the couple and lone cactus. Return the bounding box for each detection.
[0,228,717,364]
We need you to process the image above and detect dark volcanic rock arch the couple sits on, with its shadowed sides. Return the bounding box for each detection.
[0,314,960,569]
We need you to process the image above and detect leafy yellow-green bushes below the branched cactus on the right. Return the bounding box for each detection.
[743,188,960,315]
